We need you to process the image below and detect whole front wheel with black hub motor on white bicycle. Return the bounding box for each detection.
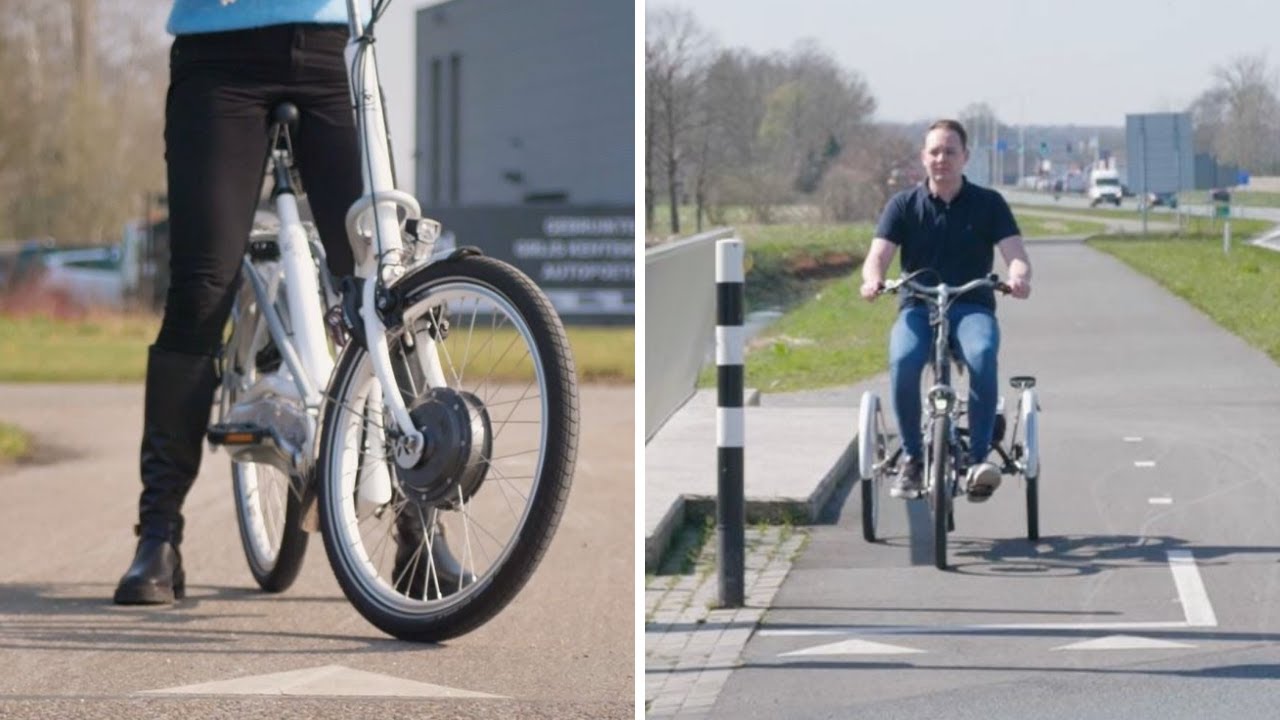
[319,256,579,642]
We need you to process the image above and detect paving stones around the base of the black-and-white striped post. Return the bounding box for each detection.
[644,525,809,720]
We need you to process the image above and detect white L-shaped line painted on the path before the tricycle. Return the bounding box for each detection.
[756,550,1217,655]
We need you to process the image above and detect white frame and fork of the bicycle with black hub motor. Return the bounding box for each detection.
[225,0,447,481]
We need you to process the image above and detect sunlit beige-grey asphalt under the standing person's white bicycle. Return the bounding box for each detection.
[0,386,635,719]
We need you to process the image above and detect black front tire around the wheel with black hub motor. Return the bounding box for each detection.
[317,255,579,642]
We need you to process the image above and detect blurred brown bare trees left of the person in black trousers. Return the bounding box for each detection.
[0,0,168,242]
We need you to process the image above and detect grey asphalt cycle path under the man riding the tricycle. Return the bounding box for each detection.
[712,237,1280,720]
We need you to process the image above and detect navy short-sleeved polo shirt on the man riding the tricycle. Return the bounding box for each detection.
[876,178,1021,311]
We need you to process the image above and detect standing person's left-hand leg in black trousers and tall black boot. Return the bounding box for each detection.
[114,38,275,605]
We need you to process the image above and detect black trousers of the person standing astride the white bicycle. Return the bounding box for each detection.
[156,24,362,356]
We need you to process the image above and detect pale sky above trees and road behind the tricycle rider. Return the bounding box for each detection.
[646,0,1280,127]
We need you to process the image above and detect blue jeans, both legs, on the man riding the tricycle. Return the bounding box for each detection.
[888,302,1000,462]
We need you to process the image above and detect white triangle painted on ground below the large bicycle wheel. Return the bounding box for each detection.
[145,665,502,698]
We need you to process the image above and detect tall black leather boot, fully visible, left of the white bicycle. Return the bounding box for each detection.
[115,346,218,605]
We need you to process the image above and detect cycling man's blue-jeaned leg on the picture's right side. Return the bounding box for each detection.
[951,305,1000,464]
